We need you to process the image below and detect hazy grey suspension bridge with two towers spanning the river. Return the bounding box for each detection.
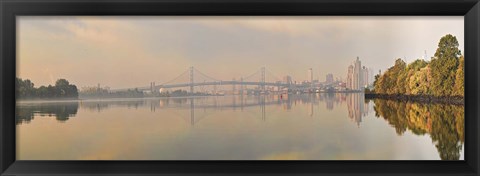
[111,67,292,93]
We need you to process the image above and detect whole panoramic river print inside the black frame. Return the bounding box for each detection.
[16,16,465,160]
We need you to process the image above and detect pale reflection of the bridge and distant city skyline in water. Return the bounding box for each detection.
[74,93,369,125]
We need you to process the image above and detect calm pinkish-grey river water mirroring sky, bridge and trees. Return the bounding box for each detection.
[15,93,464,160]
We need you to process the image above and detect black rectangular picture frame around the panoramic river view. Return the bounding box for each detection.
[0,0,480,176]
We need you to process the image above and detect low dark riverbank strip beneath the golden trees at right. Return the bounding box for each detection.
[365,93,464,105]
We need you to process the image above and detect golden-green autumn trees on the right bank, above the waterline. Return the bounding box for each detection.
[373,34,465,97]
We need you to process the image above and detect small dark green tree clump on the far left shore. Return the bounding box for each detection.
[15,78,78,99]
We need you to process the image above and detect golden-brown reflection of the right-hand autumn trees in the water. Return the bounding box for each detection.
[374,99,465,160]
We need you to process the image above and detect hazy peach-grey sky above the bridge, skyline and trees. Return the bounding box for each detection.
[17,16,464,88]
